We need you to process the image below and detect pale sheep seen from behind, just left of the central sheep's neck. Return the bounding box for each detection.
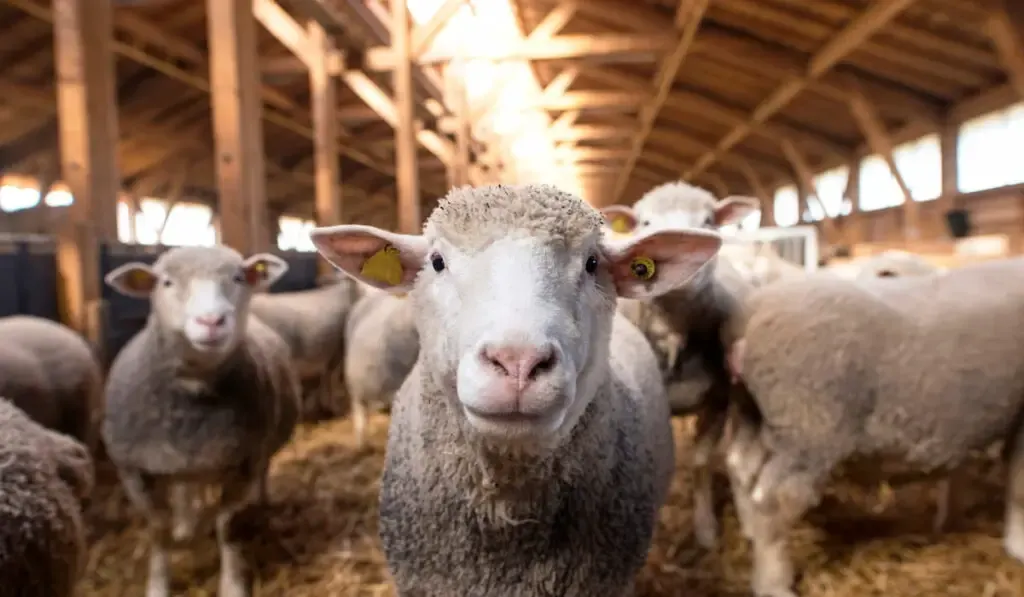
[344,289,420,447]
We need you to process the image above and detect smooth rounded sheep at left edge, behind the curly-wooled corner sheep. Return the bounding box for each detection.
[0,315,103,453]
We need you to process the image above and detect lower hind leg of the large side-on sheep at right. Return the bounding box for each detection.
[748,454,830,597]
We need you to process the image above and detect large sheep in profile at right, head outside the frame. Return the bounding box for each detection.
[726,258,1024,597]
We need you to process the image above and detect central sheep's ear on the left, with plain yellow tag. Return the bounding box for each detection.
[309,224,428,294]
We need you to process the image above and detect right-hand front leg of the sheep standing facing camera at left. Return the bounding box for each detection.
[211,479,258,597]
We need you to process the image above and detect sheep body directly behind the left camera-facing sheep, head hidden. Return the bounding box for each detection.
[249,276,359,421]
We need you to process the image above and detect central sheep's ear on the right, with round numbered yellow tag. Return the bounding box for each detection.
[601,228,722,299]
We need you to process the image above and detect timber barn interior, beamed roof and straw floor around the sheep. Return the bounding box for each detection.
[0,0,1024,597]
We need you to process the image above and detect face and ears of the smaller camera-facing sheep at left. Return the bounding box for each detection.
[105,246,288,364]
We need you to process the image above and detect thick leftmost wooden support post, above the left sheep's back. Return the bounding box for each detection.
[53,0,121,351]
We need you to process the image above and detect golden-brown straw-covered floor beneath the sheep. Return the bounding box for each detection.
[81,416,1024,597]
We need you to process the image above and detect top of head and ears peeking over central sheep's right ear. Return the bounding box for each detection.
[601,181,761,233]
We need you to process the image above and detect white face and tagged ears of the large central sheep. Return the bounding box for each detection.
[312,185,721,445]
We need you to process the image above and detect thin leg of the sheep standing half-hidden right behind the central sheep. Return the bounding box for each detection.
[693,402,728,549]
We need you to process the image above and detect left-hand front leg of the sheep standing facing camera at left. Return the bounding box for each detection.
[119,470,171,597]
